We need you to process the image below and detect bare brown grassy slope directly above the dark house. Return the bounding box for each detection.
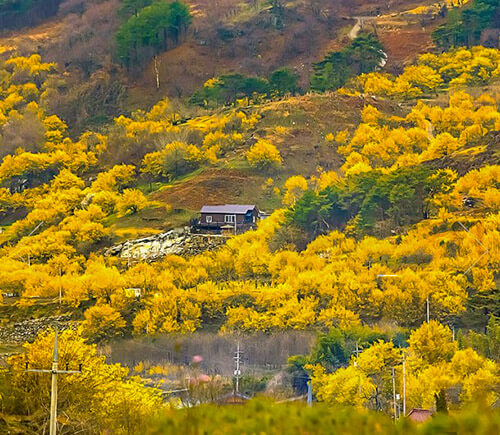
[134,93,399,223]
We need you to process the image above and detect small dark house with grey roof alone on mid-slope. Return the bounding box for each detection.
[196,204,259,232]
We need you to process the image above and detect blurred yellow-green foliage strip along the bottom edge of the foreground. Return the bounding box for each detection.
[145,400,500,435]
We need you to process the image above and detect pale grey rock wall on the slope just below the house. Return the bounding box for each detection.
[104,229,227,261]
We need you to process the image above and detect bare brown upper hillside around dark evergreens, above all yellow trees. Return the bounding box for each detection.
[0,0,446,132]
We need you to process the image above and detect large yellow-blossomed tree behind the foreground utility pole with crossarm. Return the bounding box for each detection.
[9,330,162,433]
